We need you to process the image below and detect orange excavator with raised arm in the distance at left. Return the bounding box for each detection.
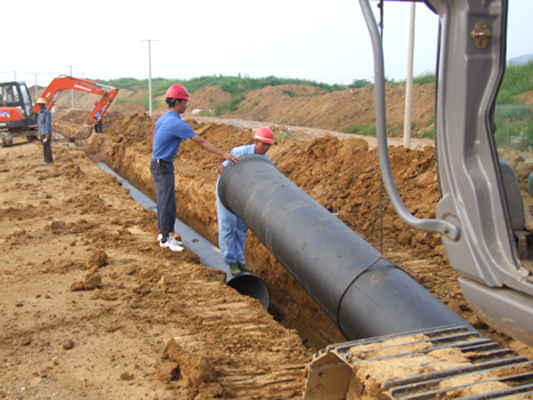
[0,75,118,145]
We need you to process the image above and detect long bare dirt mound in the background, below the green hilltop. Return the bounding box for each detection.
[187,84,435,136]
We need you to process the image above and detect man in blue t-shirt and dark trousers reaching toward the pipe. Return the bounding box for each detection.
[150,85,239,251]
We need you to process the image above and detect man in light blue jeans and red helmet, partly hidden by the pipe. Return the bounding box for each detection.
[215,127,274,276]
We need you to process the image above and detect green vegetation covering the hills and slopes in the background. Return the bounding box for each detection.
[102,62,533,144]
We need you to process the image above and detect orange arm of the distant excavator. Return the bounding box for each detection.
[34,76,118,127]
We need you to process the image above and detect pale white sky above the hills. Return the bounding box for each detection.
[0,0,533,86]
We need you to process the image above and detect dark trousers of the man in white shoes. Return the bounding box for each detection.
[150,158,176,232]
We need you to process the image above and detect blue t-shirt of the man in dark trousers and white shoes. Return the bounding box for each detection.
[152,111,196,162]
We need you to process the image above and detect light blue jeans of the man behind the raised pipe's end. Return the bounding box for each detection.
[215,180,248,265]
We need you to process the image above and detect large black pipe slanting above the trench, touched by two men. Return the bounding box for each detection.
[218,155,474,340]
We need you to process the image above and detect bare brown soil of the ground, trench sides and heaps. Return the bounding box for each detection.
[0,83,533,399]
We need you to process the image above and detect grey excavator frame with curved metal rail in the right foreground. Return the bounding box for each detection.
[360,0,533,345]
